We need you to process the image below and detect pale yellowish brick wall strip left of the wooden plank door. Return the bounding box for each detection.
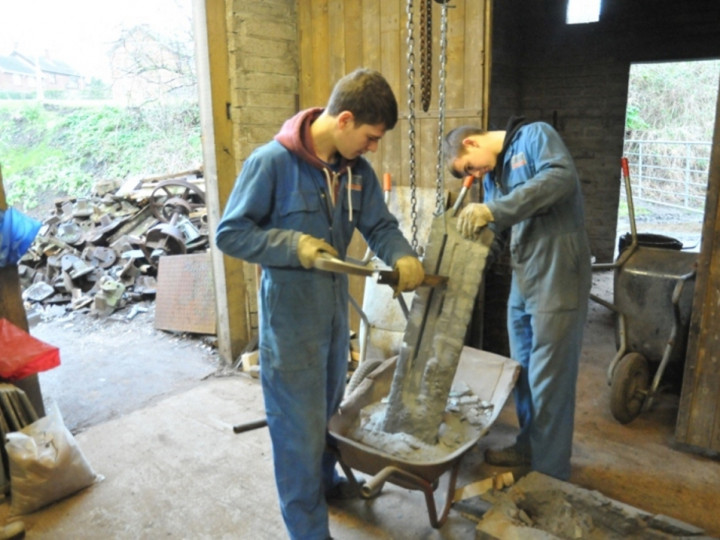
[228,0,299,162]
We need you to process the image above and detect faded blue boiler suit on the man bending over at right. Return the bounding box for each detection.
[484,119,592,480]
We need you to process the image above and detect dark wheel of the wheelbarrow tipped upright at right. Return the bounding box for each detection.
[610,353,650,424]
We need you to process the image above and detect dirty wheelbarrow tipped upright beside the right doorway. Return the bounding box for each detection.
[591,158,698,424]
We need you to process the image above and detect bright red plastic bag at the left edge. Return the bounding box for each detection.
[0,319,60,381]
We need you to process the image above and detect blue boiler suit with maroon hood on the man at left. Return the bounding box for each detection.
[216,109,415,540]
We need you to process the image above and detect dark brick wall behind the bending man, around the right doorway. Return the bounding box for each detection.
[490,0,720,262]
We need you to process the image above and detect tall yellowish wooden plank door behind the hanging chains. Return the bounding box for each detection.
[297,0,490,327]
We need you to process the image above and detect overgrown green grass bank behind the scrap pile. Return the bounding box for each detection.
[0,101,202,214]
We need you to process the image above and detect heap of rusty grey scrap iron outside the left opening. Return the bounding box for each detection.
[18,170,208,316]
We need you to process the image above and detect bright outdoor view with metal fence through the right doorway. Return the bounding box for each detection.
[618,60,720,251]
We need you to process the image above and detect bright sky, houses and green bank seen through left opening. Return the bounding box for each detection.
[0,0,202,218]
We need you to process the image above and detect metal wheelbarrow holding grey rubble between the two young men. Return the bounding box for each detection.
[328,347,520,528]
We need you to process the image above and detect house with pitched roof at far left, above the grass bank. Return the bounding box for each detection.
[0,51,83,98]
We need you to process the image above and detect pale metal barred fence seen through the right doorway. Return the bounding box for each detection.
[624,140,712,214]
